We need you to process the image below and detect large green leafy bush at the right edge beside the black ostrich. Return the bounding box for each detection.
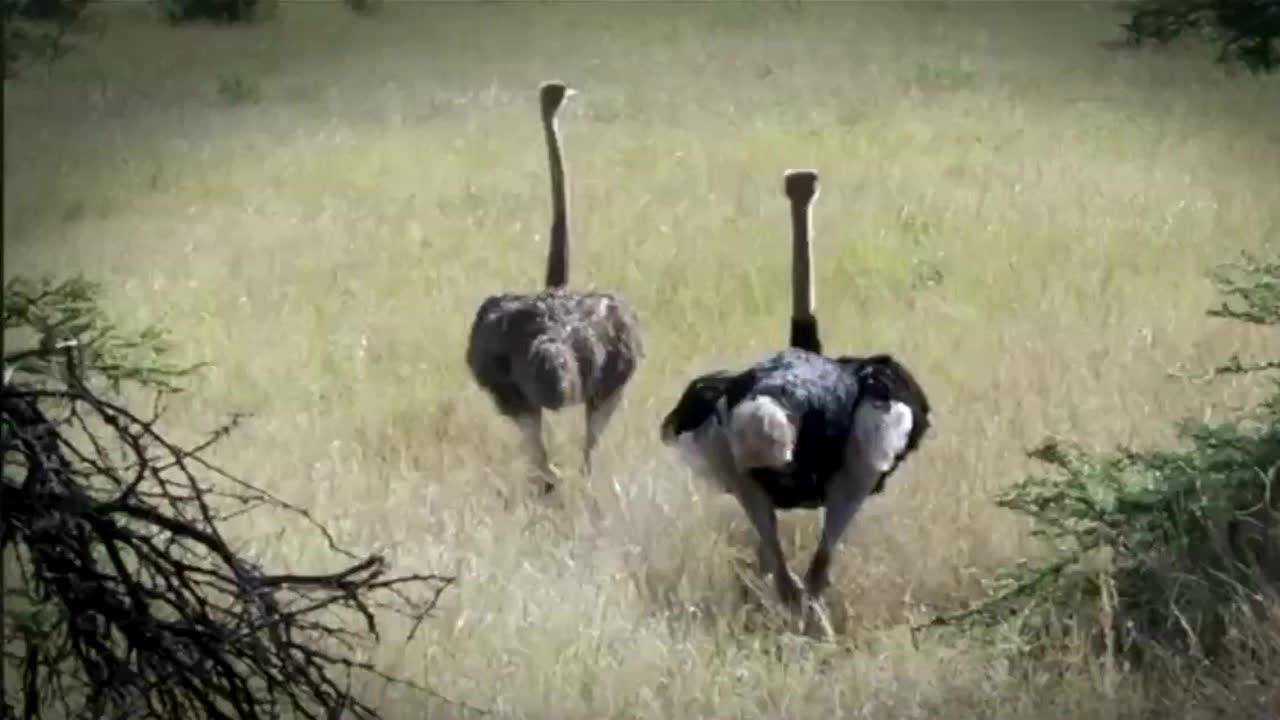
[932,255,1280,661]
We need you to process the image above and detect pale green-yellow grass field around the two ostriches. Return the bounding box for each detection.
[4,3,1280,717]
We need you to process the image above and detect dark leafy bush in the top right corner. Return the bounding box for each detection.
[1121,0,1280,72]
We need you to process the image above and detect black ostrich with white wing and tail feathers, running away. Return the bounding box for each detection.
[662,170,929,634]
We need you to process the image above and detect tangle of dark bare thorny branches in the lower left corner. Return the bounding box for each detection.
[0,357,478,719]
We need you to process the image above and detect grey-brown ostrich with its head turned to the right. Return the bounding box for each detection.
[467,82,644,493]
